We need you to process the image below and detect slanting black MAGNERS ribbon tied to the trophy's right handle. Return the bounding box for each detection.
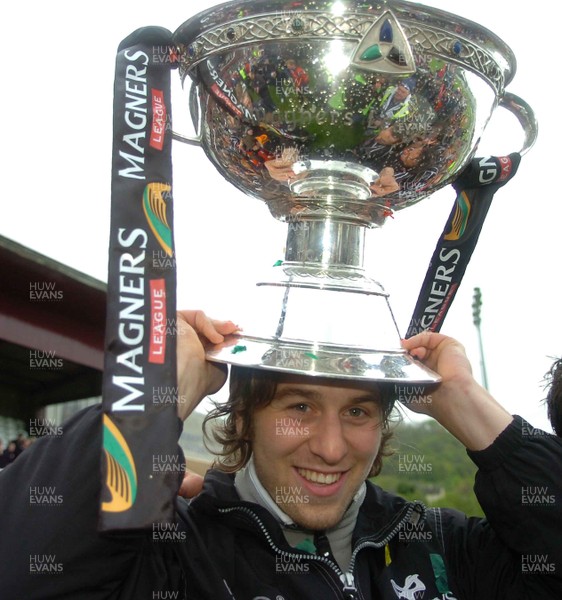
[406,153,521,337]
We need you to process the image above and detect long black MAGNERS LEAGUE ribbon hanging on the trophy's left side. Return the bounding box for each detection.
[99,27,178,530]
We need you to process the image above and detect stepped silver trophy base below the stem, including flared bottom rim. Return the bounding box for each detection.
[203,260,440,388]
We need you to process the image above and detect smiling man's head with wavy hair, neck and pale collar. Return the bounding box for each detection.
[201,367,393,573]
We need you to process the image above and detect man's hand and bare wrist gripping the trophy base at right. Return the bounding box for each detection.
[402,331,512,450]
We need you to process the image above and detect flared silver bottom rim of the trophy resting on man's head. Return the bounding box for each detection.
[203,335,441,384]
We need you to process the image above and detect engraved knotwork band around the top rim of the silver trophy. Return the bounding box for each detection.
[173,0,517,96]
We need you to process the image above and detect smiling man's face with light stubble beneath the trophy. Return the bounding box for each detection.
[252,375,382,529]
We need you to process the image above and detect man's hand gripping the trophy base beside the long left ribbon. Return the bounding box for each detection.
[177,310,240,420]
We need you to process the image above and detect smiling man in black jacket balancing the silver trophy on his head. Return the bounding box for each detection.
[0,311,562,600]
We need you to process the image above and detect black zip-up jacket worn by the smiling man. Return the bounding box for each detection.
[0,407,562,600]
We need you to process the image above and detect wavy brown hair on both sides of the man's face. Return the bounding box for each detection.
[203,366,395,477]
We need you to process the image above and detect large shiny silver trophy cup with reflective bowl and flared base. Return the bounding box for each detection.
[174,0,530,382]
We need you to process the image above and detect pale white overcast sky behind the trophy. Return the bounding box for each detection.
[0,0,562,429]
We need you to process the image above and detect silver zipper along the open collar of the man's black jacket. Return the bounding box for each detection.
[218,504,418,600]
